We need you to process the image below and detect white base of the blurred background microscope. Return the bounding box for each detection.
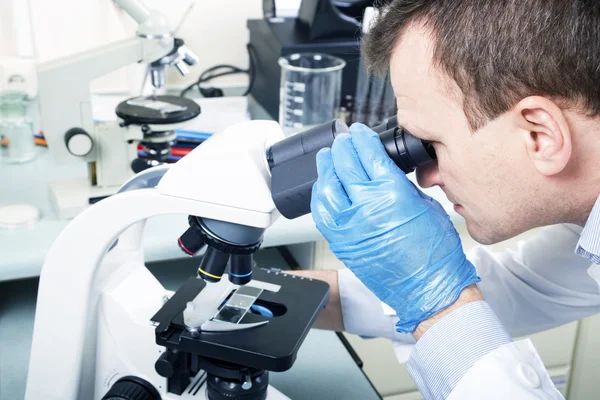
[50,177,120,219]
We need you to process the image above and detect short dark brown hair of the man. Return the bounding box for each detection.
[362,0,600,130]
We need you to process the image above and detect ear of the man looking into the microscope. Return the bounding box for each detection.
[513,96,572,176]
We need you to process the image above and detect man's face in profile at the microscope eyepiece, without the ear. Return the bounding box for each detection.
[390,27,547,244]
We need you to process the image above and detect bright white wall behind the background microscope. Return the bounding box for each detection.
[6,0,262,92]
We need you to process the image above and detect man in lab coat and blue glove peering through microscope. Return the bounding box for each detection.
[292,0,600,399]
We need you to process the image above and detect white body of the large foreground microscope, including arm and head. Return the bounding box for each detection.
[26,121,292,400]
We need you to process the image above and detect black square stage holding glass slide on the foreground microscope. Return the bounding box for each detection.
[152,269,329,371]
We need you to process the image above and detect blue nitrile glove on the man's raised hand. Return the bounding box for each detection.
[311,124,480,333]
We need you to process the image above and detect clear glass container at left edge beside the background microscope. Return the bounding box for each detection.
[0,92,35,163]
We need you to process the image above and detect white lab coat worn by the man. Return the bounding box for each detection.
[339,224,600,400]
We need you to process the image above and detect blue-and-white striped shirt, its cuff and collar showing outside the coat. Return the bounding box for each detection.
[407,196,600,400]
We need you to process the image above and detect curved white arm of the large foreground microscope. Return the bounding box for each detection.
[26,189,278,400]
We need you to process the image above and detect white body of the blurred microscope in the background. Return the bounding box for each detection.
[37,0,197,218]
